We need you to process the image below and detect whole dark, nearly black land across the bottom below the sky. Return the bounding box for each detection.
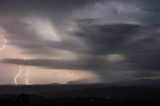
[0,84,160,106]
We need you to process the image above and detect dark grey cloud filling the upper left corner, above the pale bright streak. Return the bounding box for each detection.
[0,0,103,28]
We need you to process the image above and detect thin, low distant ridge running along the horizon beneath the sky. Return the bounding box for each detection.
[0,79,160,88]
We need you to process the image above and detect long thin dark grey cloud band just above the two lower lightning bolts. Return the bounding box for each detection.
[3,58,104,70]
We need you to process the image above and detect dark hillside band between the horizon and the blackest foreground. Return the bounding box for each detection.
[0,79,160,97]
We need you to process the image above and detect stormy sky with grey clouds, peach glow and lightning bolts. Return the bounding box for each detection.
[0,0,160,84]
